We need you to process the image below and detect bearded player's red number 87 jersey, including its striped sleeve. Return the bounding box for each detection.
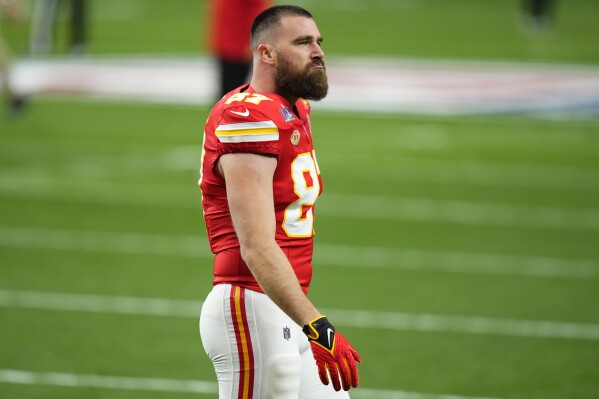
[200,85,322,292]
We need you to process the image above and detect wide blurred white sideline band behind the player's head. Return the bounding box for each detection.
[8,56,599,118]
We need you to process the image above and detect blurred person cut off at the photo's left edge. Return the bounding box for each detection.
[0,0,25,114]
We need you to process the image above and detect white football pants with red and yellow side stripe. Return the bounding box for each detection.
[200,284,349,399]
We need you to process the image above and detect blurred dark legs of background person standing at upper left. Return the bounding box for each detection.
[29,0,89,56]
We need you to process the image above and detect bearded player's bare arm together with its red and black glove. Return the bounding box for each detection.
[218,153,360,391]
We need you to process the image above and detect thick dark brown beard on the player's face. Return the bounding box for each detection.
[275,58,329,101]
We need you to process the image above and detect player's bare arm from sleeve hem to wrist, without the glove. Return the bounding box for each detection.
[219,153,320,326]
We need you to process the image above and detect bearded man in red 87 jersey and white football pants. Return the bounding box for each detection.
[199,6,360,399]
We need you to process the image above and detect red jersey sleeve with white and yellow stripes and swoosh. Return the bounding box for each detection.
[214,106,279,157]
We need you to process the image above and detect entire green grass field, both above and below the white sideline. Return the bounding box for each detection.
[0,0,599,399]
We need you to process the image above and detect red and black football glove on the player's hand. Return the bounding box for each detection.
[303,316,362,391]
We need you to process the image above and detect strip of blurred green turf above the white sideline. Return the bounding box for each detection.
[4,0,599,64]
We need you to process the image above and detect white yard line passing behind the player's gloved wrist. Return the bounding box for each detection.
[0,290,599,341]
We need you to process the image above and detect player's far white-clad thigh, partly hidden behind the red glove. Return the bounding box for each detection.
[299,336,349,399]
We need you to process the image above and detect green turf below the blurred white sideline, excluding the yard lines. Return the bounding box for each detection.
[0,100,599,398]
